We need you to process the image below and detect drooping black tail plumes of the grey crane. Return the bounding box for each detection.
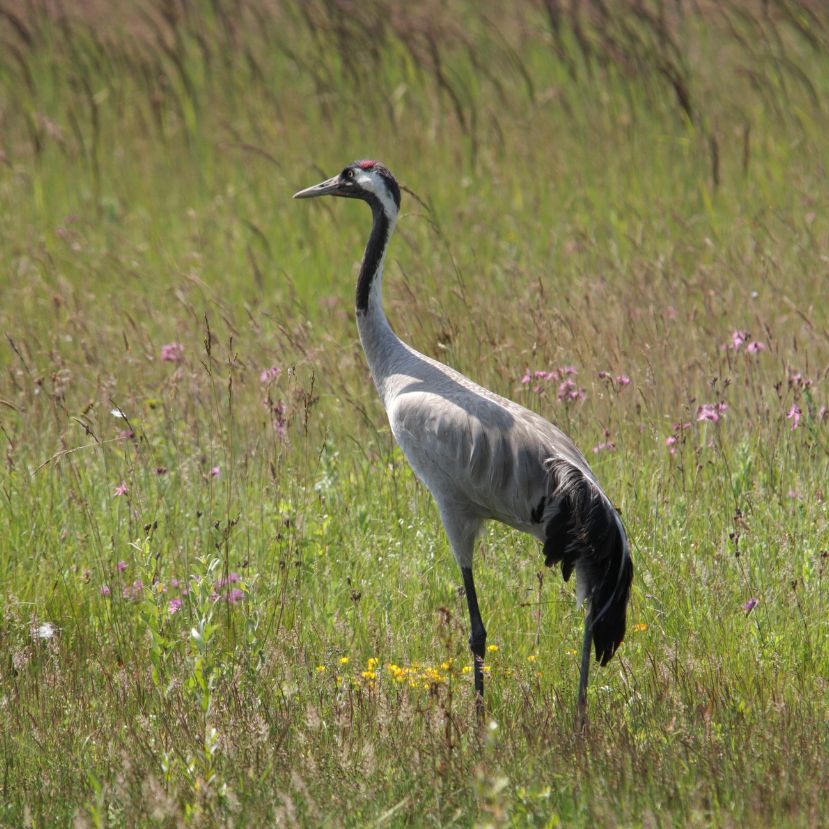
[542,460,633,665]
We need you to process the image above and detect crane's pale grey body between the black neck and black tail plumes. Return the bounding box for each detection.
[366,320,593,567]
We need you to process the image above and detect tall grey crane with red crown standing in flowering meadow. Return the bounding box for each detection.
[294,160,633,723]
